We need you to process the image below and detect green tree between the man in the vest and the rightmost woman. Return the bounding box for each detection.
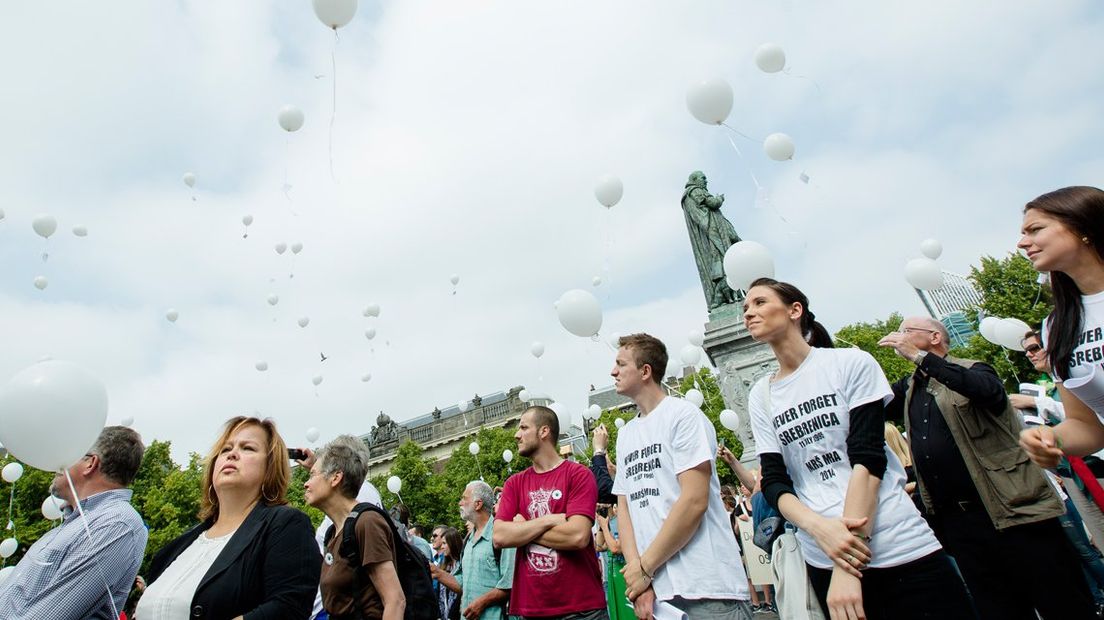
[951,249,1054,391]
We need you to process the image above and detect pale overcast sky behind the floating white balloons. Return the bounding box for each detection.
[0,0,1104,458]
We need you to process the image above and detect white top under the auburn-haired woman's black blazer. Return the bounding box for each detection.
[135,525,234,620]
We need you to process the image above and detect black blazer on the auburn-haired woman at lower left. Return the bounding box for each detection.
[149,503,322,620]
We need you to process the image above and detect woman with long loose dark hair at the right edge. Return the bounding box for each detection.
[1017,186,1104,467]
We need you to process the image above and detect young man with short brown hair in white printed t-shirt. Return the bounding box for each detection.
[609,333,752,620]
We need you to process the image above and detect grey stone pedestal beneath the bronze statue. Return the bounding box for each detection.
[704,303,778,467]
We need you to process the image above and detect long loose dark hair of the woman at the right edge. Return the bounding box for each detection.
[1023,185,1104,380]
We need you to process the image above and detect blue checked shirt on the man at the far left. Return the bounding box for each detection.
[0,489,149,620]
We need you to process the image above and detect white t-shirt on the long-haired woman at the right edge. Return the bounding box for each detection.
[1042,292,1104,424]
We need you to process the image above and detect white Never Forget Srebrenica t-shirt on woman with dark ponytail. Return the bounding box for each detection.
[747,349,941,568]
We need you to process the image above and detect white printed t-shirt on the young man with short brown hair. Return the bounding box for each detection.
[613,396,749,600]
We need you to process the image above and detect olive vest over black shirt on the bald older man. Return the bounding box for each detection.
[904,353,1065,530]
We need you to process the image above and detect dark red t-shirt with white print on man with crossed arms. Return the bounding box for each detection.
[495,461,606,617]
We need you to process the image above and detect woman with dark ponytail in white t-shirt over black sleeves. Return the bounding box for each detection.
[744,278,975,620]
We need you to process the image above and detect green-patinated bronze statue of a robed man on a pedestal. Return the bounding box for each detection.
[682,171,743,312]
